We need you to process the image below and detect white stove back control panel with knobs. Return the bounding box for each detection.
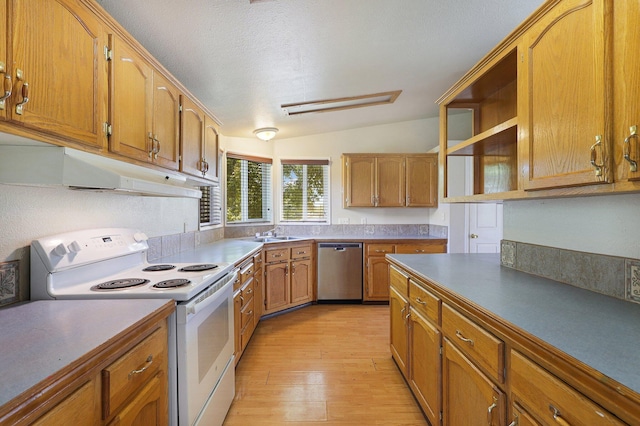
[31,228,149,272]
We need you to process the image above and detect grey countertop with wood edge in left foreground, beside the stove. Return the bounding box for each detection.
[0,299,175,414]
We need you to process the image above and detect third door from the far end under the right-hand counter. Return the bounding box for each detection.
[442,338,506,426]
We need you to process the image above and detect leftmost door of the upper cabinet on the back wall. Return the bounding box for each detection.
[345,157,376,207]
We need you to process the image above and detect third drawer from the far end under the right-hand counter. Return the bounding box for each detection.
[442,303,504,383]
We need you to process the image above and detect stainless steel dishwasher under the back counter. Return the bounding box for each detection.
[318,243,362,302]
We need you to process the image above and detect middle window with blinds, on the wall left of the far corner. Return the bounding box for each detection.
[227,153,272,223]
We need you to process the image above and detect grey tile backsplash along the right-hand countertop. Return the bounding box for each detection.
[500,240,640,303]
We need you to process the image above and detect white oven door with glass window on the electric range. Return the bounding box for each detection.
[176,270,238,426]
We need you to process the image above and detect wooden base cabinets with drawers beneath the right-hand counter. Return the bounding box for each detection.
[390,259,640,426]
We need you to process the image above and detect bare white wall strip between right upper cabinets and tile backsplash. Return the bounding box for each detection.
[504,194,640,259]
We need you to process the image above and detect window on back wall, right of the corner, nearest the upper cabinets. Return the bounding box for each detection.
[280,160,329,222]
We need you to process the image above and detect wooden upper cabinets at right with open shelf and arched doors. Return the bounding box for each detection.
[439,0,640,202]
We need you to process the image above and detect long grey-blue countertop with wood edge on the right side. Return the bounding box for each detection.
[387,254,640,393]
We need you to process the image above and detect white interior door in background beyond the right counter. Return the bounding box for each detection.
[469,203,502,253]
